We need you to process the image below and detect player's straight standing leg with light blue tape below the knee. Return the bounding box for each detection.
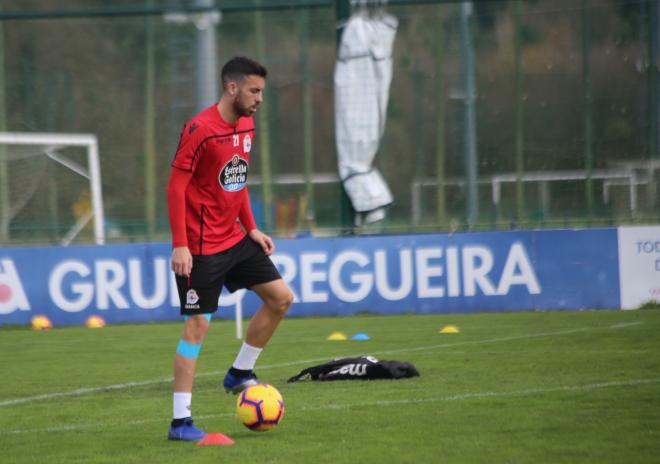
[168,314,211,441]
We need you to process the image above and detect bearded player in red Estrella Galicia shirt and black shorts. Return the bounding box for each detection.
[167,57,293,441]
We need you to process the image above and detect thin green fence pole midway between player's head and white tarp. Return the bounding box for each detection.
[299,10,316,227]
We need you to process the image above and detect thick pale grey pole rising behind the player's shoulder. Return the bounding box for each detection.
[195,0,218,111]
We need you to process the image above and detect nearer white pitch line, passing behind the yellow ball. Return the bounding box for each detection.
[0,378,660,436]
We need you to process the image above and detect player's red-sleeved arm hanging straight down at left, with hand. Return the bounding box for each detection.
[167,167,192,276]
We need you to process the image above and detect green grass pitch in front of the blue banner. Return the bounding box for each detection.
[0,310,660,464]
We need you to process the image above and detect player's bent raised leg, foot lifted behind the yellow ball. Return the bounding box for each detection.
[223,279,293,393]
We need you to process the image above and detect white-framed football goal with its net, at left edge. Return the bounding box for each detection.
[0,132,105,245]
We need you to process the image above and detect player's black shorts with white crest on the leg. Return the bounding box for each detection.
[176,236,281,315]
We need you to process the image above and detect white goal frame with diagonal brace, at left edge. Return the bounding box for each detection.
[0,132,105,245]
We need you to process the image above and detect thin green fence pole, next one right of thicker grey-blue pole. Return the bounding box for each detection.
[513,0,525,221]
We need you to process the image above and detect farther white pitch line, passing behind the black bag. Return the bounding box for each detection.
[0,322,643,408]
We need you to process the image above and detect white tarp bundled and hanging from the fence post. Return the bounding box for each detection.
[334,8,398,222]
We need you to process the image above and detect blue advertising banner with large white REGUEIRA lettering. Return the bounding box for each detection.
[0,228,620,325]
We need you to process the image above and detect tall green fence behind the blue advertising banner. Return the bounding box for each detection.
[0,0,660,244]
